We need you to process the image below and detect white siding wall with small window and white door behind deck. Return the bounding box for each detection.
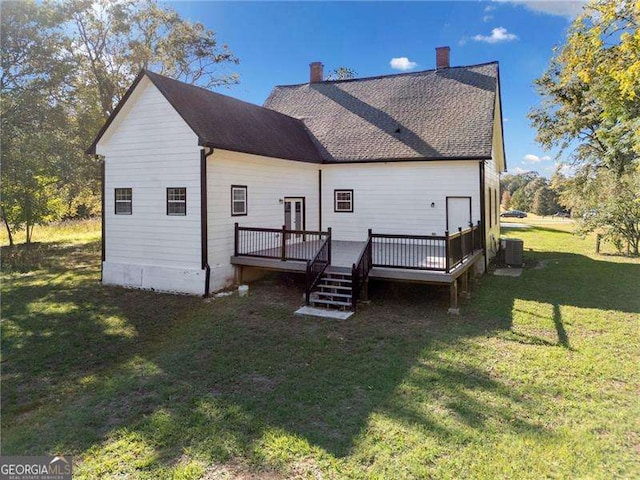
[322,161,480,241]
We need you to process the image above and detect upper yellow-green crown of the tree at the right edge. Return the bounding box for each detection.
[529,0,640,175]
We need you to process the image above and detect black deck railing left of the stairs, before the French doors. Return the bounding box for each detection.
[234,223,330,262]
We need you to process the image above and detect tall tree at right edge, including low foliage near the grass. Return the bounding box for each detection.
[529,0,640,252]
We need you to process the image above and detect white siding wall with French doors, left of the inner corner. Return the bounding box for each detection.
[207,150,320,291]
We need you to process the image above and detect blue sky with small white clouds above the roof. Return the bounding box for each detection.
[171,1,581,176]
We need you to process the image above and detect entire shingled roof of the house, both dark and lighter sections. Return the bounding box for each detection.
[88,62,502,167]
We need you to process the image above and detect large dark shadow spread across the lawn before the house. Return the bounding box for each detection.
[2,233,638,476]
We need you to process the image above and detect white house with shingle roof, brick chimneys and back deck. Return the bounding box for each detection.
[89,47,506,309]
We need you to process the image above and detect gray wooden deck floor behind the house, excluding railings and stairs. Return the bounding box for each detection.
[231,240,482,284]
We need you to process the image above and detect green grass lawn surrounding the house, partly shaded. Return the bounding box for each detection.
[1,219,640,479]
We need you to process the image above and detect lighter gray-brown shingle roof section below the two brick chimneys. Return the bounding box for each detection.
[264,62,498,162]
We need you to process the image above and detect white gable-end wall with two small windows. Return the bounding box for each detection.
[97,78,204,294]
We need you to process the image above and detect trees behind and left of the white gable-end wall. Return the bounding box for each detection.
[0,0,238,245]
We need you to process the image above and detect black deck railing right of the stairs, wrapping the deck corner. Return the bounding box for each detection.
[369,222,482,273]
